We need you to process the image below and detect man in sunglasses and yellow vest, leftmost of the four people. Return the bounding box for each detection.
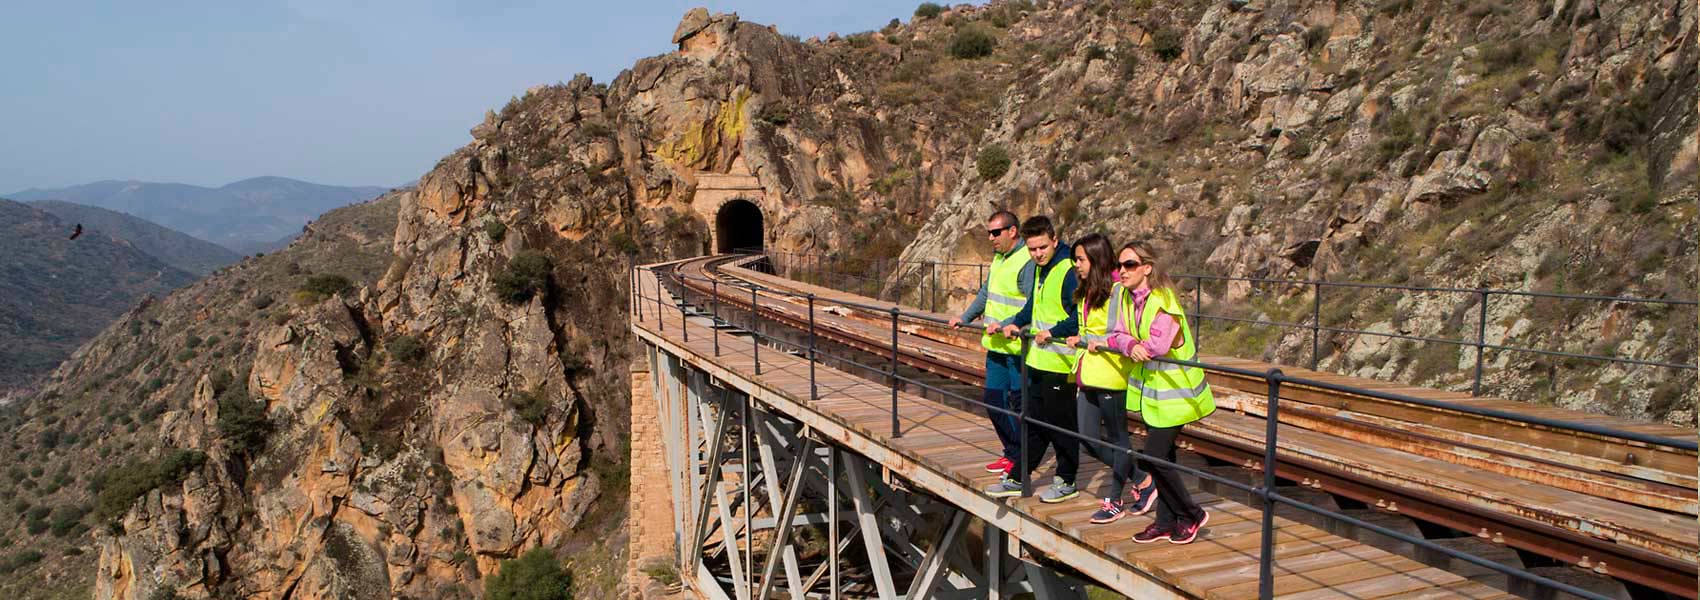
[950,211,1034,473]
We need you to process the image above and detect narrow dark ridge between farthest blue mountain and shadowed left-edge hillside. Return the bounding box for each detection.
[29,201,241,277]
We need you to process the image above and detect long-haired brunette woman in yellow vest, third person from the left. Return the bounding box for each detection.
[1068,233,1156,524]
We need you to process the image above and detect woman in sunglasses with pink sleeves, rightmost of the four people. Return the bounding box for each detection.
[1108,243,1216,544]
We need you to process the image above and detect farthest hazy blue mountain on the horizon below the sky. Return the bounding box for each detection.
[9,177,389,253]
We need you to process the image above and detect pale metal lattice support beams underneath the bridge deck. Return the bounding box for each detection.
[643,343,1083,600]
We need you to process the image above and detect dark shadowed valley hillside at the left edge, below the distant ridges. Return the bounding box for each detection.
[0,201,196,398]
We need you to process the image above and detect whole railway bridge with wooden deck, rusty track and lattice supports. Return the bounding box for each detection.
[629,255,1700,600]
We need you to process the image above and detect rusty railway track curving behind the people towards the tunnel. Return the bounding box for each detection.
[652,257,1700,598]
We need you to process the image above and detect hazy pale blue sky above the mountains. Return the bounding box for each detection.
[0,0,916,194]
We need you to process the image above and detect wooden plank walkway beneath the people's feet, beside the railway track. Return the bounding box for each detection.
[632,266,1511,598]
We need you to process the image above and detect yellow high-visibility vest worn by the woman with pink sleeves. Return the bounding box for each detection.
[1125,289,1216,427]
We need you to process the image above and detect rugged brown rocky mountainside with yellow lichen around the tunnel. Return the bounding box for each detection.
[0,0,1697,600]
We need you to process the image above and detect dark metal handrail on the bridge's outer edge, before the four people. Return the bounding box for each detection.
[632,267,1632,600]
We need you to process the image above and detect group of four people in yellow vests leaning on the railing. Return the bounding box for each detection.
[950,211,1216,544]
